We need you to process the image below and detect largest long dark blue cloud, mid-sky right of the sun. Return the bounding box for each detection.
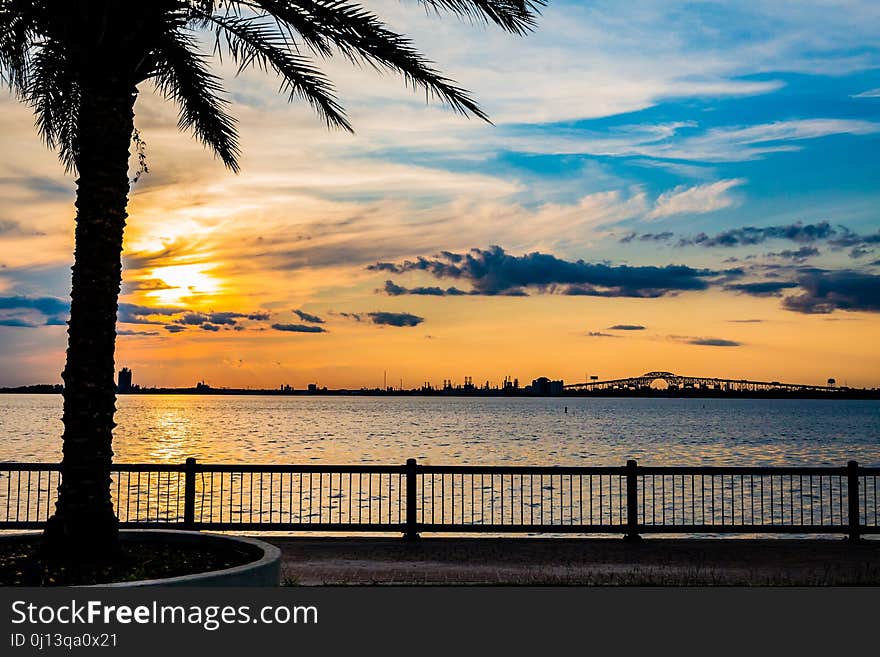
[368,246,724,298]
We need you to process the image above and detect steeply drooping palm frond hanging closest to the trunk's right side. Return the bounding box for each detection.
[153,31,240,172]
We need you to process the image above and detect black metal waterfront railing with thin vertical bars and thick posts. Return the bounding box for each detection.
[0,459,880,539]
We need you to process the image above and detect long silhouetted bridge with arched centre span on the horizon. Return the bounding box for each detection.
[565,372,848,392]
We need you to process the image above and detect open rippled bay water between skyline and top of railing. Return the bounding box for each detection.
[0,395,880,466]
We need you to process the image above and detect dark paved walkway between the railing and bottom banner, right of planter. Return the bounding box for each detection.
[263,536,880,586]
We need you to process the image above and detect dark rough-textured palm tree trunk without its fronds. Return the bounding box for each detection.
[45,80,137,559]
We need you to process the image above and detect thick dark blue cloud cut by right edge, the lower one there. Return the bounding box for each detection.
[782,270,880,314]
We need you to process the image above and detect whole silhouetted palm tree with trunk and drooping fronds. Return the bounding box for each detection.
[0,0,544,557]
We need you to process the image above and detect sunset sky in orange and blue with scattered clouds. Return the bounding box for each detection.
[0,0,880,388]
